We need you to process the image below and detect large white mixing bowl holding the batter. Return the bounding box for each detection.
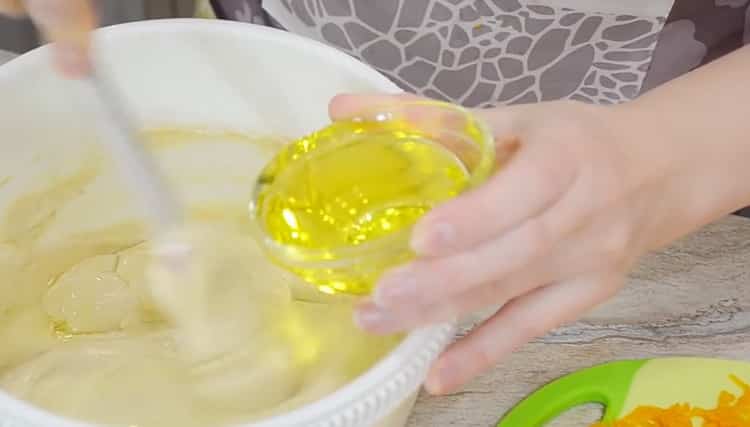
[0,20,453,427]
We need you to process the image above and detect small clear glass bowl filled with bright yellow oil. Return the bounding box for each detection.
[251,102,495,295]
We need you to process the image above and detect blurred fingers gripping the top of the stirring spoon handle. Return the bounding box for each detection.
[0,0,96,77]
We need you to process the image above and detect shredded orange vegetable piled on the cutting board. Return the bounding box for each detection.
[591,375,750,427]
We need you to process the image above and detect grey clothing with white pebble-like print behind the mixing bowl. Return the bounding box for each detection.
[212,0,750,107]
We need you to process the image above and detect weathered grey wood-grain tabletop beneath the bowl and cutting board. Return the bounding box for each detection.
[409,217,750,427]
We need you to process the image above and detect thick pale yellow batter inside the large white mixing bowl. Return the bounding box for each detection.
[0,131,396,427]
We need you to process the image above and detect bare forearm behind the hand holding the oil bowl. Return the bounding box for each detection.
[618,47,750,246]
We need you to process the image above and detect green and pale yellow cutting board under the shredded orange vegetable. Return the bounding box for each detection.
[498,358,750,427]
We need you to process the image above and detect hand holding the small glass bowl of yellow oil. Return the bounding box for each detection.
[331,89,736,393]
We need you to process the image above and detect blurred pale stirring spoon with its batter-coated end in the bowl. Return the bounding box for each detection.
[88,61,274,366]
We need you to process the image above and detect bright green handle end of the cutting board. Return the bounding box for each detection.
[497,360,645,427]
